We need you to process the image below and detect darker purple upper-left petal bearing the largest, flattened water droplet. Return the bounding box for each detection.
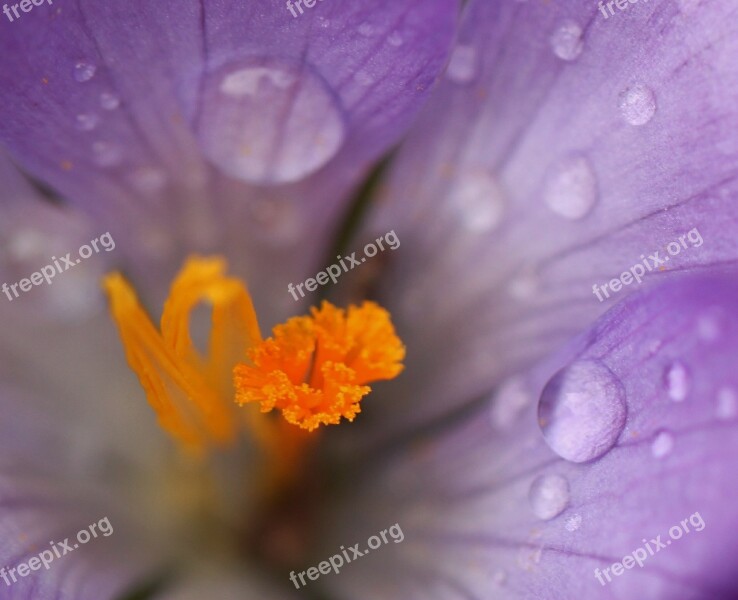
[0,0,457,323]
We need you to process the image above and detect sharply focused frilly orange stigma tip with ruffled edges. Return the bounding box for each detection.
[234,302,405,431]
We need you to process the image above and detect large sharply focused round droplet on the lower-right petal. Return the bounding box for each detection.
[538,360,627,463]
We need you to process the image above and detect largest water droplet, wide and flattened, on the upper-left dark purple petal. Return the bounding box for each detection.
[199,59,345,184]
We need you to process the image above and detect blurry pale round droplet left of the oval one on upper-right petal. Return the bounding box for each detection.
[450,172,504,233]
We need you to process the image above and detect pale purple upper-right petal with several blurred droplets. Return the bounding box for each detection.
[342,0,738,440]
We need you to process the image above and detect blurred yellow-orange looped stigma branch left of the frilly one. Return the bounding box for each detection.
[103,257,261,450]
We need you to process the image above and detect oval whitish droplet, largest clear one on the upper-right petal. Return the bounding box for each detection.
[543,155,597,219]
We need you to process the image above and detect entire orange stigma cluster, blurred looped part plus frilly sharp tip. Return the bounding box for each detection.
[103,257,405,454]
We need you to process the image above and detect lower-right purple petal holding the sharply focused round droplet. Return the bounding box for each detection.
[330,271,738,600]
